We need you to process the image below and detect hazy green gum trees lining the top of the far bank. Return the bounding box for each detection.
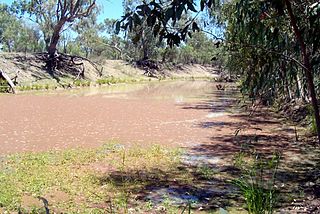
[0,0,219,64]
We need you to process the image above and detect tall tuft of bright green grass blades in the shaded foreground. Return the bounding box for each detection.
[232,152,280,214]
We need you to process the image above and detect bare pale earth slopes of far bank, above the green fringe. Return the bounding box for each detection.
[0,53,219,87]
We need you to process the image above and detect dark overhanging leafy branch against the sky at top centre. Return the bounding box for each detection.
[116,0,213,47]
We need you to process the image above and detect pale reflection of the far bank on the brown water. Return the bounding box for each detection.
[26,81,235,104]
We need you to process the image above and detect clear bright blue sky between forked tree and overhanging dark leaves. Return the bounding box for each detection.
[0,0,123,22]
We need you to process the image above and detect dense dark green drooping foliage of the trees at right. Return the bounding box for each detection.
[224,0,320,104]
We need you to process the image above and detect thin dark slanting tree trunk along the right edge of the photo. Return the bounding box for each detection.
[285,0,320,143]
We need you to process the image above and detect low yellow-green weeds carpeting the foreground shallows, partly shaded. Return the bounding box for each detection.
[0,142,258,213]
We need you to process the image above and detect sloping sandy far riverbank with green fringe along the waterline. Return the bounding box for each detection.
[0,53,219,91]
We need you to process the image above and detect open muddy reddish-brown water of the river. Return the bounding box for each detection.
[0,81,241,154]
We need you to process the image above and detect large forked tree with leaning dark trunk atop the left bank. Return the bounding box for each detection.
[13,0,96,74]
